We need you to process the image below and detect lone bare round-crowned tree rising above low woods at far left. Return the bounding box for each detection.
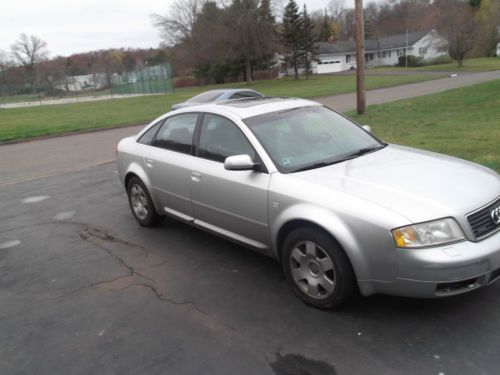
[11,34,48,92]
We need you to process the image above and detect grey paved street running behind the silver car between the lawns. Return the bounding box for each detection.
[0,71,500,185]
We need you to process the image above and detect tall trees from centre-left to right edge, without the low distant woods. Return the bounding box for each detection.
[153,0,500,84]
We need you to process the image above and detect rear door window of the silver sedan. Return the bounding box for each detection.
[153,113,198,154]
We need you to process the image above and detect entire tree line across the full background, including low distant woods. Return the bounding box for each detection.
[0,0,500,94]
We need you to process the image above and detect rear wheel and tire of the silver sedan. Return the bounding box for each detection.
[127,177,162,227]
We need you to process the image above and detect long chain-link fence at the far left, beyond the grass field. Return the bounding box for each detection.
[0,63,174,108]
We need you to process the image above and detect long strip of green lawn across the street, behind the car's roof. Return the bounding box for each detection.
[0,74,439,141]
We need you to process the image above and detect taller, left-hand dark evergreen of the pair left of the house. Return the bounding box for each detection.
[281,0,302,79]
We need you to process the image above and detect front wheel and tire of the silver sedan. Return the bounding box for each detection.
[281,228,357,310]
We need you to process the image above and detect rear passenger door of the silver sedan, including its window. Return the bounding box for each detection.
[145,113,199,221]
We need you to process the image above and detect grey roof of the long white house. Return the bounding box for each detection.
[318,31,429,55]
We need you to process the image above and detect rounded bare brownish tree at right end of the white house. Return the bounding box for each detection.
[436,0,476,66]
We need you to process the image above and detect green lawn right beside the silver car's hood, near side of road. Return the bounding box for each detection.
[348,80,500,172]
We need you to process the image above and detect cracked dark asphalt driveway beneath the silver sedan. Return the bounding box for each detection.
[0,163,500,375]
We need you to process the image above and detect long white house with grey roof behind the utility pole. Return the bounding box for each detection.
[313,30,446,74]
